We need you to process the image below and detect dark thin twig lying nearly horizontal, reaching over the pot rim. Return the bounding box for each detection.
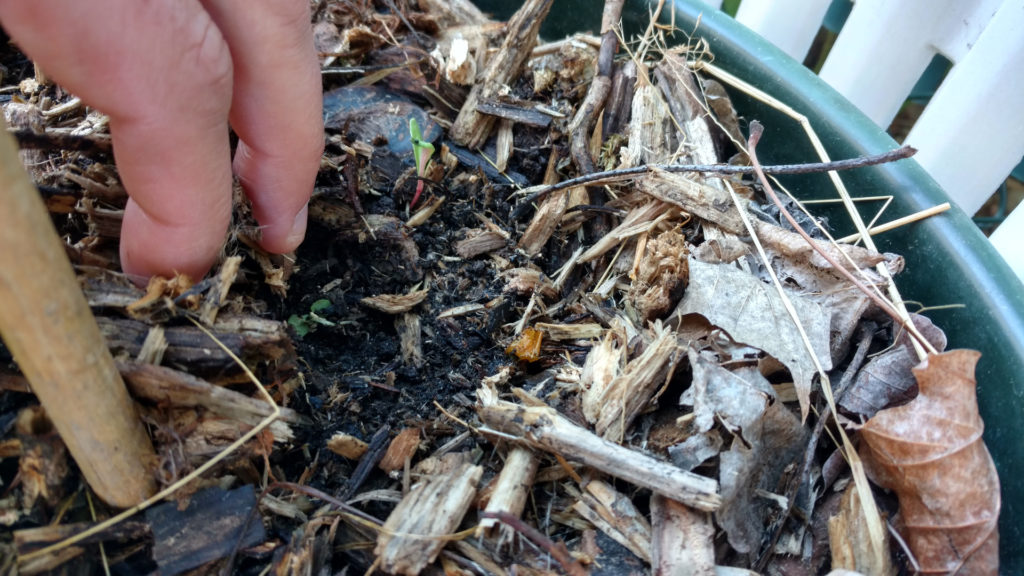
[512,144,918,219]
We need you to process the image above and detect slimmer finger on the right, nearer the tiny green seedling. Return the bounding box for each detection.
[204,0,324,253]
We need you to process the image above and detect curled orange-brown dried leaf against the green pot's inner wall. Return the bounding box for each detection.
[861,349,1000,574]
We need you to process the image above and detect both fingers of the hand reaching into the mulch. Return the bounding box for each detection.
[0,0,324,282]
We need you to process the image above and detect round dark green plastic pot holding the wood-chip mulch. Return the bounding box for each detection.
[479,0,1024,574]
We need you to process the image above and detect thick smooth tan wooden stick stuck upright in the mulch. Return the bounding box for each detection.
[0,124,156,507]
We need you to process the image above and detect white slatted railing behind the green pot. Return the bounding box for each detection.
[706,0,1024,280]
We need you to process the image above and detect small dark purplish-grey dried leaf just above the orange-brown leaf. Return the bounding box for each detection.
[839,315,946,418]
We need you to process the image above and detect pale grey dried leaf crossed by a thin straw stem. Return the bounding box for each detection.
[675,258,831,418]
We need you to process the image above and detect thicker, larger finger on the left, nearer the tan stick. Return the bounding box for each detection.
[0,0,232,278]
